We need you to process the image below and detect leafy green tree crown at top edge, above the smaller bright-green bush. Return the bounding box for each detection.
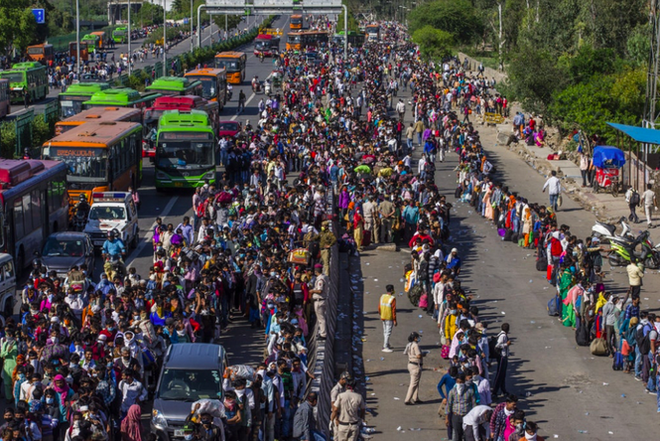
[408,0,483,43]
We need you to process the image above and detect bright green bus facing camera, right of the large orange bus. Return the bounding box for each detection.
[154,110,216,191]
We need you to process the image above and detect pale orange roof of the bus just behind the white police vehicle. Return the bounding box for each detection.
[44,121,142,147]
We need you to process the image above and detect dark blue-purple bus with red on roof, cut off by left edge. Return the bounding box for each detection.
[0,159,69,272]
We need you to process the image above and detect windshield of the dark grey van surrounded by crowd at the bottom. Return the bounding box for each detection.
[158,369,222,403]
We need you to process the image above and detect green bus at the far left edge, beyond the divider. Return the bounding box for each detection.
[0,61,48,103]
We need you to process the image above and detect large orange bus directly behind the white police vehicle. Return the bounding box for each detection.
[42,121,142,205]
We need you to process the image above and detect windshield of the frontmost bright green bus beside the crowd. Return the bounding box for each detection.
[156,140,214,170]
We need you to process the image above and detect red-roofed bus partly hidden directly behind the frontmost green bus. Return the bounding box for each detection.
[142,95,220,158]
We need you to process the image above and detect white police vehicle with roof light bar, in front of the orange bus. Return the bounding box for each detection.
[84,191,140,248]
